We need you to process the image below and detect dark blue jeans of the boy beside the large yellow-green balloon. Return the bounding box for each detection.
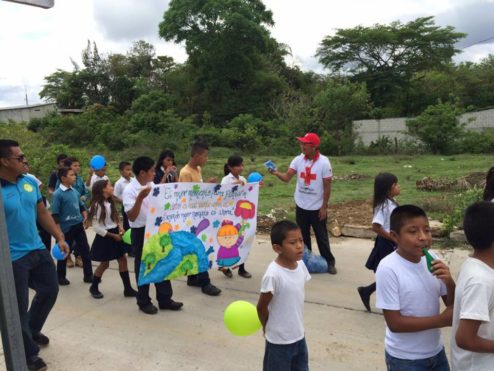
[262,338,309,371]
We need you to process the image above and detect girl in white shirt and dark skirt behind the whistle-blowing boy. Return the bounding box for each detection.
[357,173,400,312]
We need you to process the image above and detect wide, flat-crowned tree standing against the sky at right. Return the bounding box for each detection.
[317,17,466,115]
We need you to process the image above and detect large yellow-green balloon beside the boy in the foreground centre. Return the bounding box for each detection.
[223,300,261,336]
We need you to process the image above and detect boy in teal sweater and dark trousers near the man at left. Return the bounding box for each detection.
[51,167,93,286]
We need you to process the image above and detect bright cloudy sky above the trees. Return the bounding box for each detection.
[0,0,494,108]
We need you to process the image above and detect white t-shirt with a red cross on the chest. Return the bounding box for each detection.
[290,154,333,210]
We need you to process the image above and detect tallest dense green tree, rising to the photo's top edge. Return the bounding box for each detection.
[159,0,285,122]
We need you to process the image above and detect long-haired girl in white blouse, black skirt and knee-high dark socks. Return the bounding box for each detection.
[88,180,137,299]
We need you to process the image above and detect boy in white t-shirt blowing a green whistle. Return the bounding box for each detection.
[376,205,455,371]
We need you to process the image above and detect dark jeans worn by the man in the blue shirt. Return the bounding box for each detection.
[12,248,58,359]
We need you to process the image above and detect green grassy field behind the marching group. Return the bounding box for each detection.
[103,149,494,219]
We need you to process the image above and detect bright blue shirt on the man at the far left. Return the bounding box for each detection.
[0,175,46,261]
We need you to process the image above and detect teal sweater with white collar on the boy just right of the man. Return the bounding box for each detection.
[51,184,86,233]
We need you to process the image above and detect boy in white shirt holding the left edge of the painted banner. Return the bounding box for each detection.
[122,156,183,314]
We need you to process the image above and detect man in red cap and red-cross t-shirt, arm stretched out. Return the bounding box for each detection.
[269,133,336,274]
